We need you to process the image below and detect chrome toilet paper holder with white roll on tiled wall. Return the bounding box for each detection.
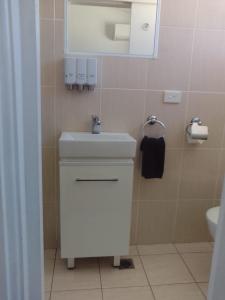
[186,117,208,144]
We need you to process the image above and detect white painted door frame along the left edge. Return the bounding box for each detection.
[0,0,44,300]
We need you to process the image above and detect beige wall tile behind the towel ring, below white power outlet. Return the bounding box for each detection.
[145,91,187,148]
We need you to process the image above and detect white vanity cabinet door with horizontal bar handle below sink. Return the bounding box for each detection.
[60,165,133,258]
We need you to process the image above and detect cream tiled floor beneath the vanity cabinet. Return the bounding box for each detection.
[45,243,213,300]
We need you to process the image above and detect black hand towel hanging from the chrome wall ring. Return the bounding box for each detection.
[141,136,165,178]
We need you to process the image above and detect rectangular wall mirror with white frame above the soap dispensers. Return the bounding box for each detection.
[65,0,160,58]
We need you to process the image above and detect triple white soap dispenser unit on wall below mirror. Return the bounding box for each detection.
[64,56,97,92]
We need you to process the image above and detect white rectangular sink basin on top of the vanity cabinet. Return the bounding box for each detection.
[59,132,136,158]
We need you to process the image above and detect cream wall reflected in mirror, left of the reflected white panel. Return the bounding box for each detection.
[67,5,131,54]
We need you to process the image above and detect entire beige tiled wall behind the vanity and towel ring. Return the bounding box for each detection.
[41,0,225,247]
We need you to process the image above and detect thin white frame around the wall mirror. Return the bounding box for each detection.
[64,0,161,59]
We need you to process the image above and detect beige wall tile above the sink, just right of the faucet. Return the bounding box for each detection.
[101,90,145,137]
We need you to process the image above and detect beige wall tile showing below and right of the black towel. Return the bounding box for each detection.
[140,149,181,202]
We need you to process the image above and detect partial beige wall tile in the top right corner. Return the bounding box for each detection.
[198,0,225,29]
